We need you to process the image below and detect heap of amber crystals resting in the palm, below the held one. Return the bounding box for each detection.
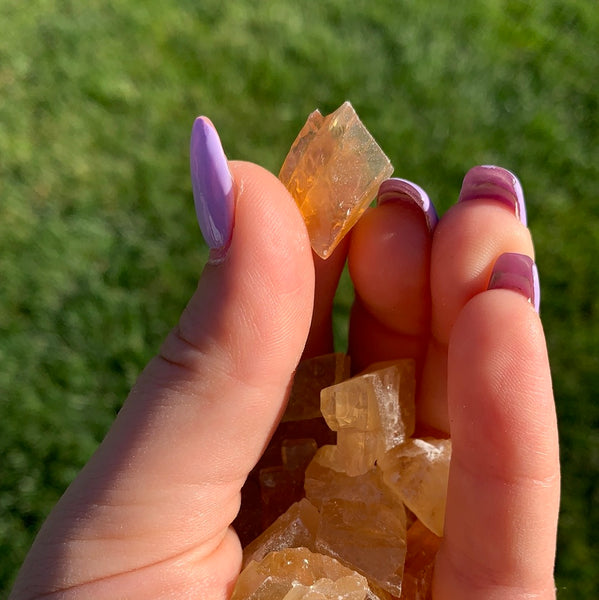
[233,354,451,600]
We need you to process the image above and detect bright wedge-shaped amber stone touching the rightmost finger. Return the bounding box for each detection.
[378,438,451,536]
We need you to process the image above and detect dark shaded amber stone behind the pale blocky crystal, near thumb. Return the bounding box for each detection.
[283,352,350,422]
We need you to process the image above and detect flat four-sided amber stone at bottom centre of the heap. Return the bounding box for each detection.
[316,499,406,596]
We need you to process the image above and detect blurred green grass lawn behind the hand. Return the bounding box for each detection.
[0,0,599,598]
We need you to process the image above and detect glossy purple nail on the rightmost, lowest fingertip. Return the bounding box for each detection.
[487,252,541,312]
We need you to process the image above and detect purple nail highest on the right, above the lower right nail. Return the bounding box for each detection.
[459,165,527,225]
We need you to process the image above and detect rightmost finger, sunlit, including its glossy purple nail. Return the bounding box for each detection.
[434,255,559,600]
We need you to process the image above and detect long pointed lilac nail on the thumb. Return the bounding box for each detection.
[189,117,235,250]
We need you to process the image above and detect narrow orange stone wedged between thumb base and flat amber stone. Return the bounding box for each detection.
[243,498,320,567]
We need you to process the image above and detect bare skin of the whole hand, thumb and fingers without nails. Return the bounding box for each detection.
[11,162,559,600]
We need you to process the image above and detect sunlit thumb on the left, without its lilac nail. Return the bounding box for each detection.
[13,126,314,598]
